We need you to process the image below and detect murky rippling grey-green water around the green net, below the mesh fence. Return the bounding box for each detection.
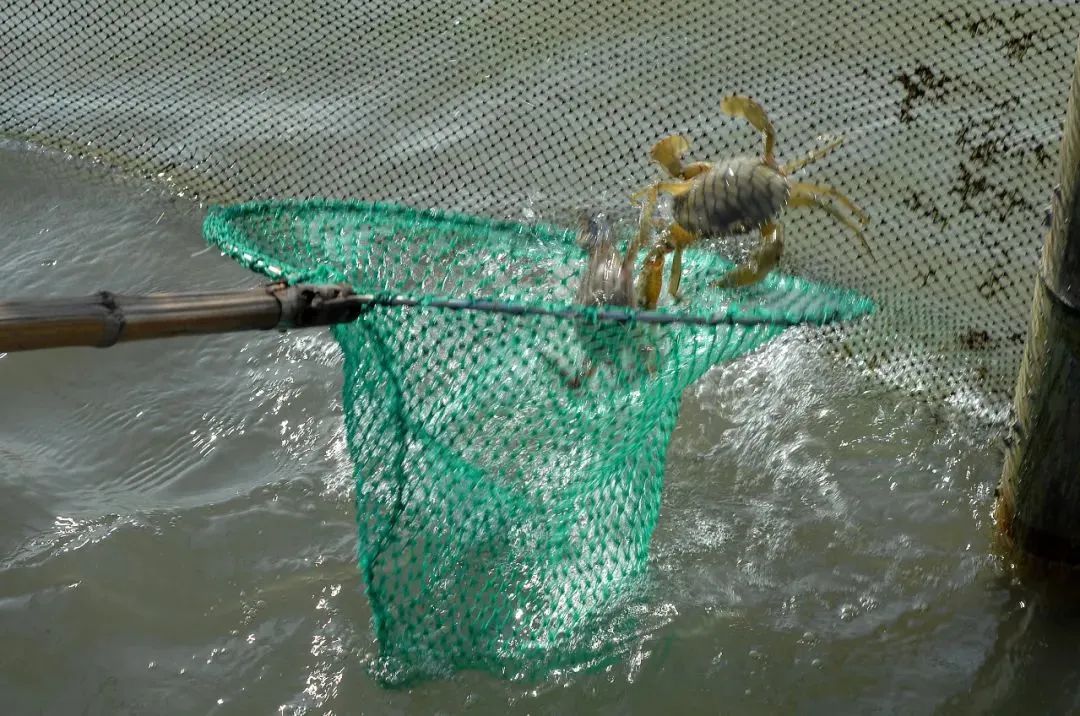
[0,138,1080,714]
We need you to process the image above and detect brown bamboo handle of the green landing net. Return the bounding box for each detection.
[0,284,372,352]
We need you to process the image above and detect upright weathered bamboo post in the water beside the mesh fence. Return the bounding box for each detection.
[995,35,1080,565]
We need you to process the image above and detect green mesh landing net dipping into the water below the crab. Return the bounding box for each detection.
[204,201,873,684]
